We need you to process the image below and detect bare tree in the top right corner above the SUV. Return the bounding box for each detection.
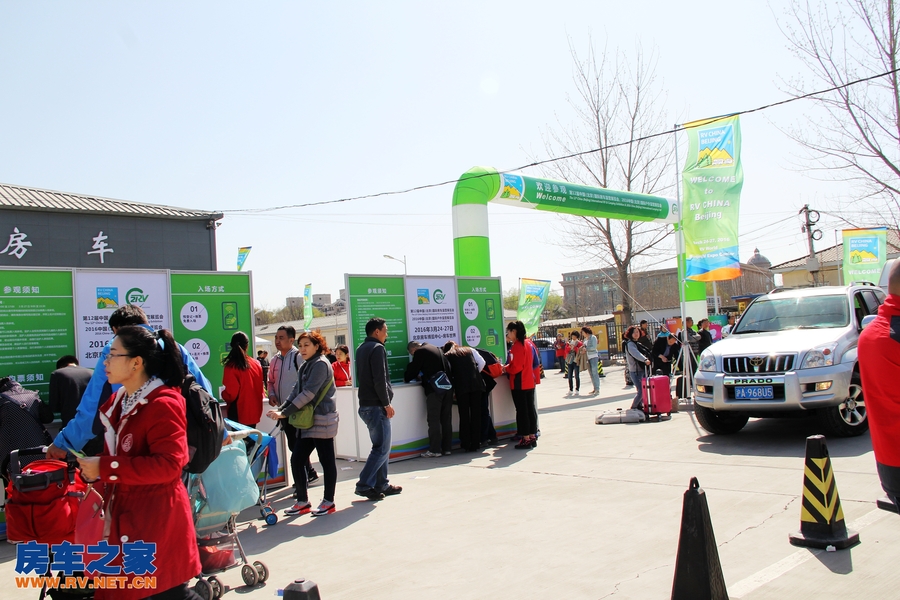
[781,0,900,228]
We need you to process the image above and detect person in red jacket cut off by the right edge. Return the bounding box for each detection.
[848,261,900,506]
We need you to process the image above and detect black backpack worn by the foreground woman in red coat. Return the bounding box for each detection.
[181,373,225,473]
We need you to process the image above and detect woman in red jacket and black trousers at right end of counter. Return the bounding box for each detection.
[503,321,540,450]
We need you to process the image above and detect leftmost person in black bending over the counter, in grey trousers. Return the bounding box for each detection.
[403,342,453,458]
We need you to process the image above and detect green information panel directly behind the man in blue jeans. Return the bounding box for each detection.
[347,275,409,382]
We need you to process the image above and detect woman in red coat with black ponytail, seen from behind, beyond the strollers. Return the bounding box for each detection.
[222,331,264,429]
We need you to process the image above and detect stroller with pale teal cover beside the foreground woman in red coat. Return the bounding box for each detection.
[188,429,269,600]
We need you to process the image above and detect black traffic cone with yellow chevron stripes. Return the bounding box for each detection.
[788,435,859,550]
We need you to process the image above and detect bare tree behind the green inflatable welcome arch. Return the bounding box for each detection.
[544,40,673,316]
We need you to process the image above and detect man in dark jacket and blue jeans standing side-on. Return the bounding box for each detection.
[355,317,403,500]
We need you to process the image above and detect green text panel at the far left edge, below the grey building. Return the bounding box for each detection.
[0,269,75,402]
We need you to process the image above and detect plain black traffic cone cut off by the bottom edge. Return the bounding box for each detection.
[672,477,728,600]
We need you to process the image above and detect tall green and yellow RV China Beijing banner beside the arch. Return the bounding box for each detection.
[682,116,744,281]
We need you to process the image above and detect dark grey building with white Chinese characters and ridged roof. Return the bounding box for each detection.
[0,184,222,271]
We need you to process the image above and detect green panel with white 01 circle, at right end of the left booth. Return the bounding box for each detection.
[171,272,255,397]
